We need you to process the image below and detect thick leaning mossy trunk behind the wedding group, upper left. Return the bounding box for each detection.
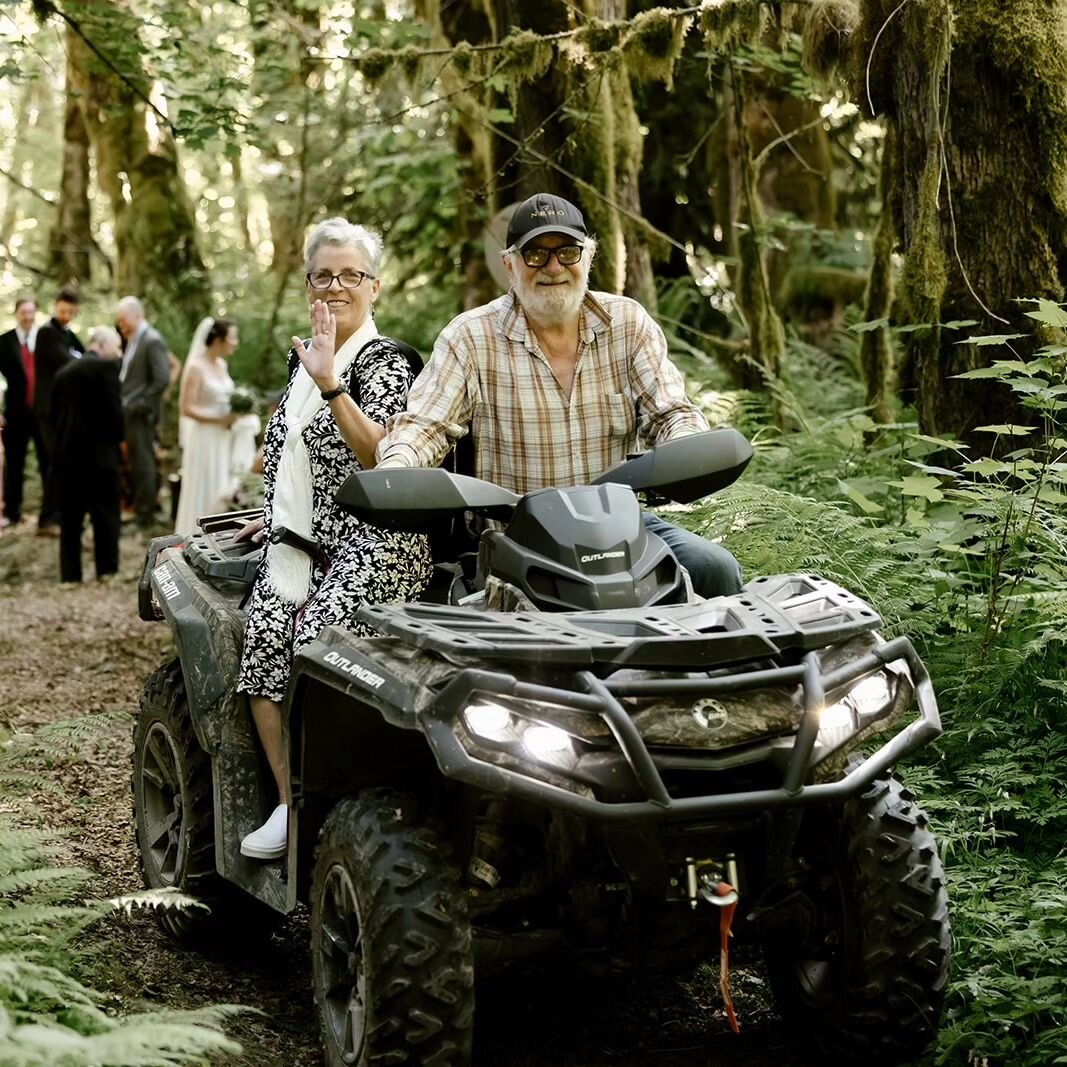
[70,0,210,329]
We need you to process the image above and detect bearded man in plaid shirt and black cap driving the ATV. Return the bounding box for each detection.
[378,193,742,596]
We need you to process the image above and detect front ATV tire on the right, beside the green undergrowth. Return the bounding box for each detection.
[764,779,952,1067]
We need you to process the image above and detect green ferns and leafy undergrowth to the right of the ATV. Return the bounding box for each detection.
[684,320,1067,1067]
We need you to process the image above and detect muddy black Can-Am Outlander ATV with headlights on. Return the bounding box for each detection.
[133,430,950,1067]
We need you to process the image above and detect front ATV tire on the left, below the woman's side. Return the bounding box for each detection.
[312,790,474,1067]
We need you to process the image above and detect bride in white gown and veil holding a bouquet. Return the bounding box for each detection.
[174,318,238,534]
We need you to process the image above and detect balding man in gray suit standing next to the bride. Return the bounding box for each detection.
[115,297,171,527]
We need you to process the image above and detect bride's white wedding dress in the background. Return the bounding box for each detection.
[174,369,234,534]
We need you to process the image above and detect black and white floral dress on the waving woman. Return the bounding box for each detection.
[237,337,431,703]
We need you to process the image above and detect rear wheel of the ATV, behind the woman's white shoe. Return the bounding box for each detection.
[131,659,281,943]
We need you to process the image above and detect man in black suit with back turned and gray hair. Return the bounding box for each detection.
[52,327,123,582]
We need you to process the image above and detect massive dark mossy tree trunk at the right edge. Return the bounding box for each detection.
[856,0,1067,447]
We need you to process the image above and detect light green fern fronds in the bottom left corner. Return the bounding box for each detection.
[0,716,240,1067]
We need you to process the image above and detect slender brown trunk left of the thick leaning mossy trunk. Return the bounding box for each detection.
[48,30,94,285]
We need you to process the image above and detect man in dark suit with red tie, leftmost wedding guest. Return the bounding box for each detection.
[0,297,40,526]
